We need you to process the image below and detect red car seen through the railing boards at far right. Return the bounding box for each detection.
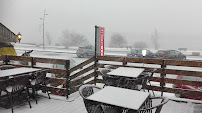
[173,75,202,100]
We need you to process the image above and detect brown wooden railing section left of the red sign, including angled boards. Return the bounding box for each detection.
[0,55,94,97]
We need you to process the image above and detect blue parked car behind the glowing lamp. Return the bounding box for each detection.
[127,49,155,58]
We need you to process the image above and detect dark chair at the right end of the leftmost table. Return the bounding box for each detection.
[29,70,50,104]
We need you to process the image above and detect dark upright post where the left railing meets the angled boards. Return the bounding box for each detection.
[65,60,70,99]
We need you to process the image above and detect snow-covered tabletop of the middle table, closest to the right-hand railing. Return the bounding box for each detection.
[107,67,145,78]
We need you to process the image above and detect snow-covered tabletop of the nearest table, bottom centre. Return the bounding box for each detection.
[87,86,150,110]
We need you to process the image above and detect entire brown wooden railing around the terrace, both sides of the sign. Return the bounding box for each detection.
[0,56,202,100]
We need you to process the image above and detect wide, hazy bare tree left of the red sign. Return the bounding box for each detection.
[61,30,89,48]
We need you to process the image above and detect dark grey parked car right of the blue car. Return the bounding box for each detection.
[155,50,186,60]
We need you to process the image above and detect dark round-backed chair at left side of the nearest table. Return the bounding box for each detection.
[79,84,104,113]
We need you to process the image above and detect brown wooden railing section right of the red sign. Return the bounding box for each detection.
[95,56,202,97]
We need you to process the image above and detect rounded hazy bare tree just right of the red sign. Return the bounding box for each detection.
[109,33,127,48]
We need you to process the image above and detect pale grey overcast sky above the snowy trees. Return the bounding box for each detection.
[0,0,202,50]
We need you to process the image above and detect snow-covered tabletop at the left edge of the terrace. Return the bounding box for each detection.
[0,67,41,78]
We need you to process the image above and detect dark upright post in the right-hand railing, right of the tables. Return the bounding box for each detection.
[160,60,166,96]
